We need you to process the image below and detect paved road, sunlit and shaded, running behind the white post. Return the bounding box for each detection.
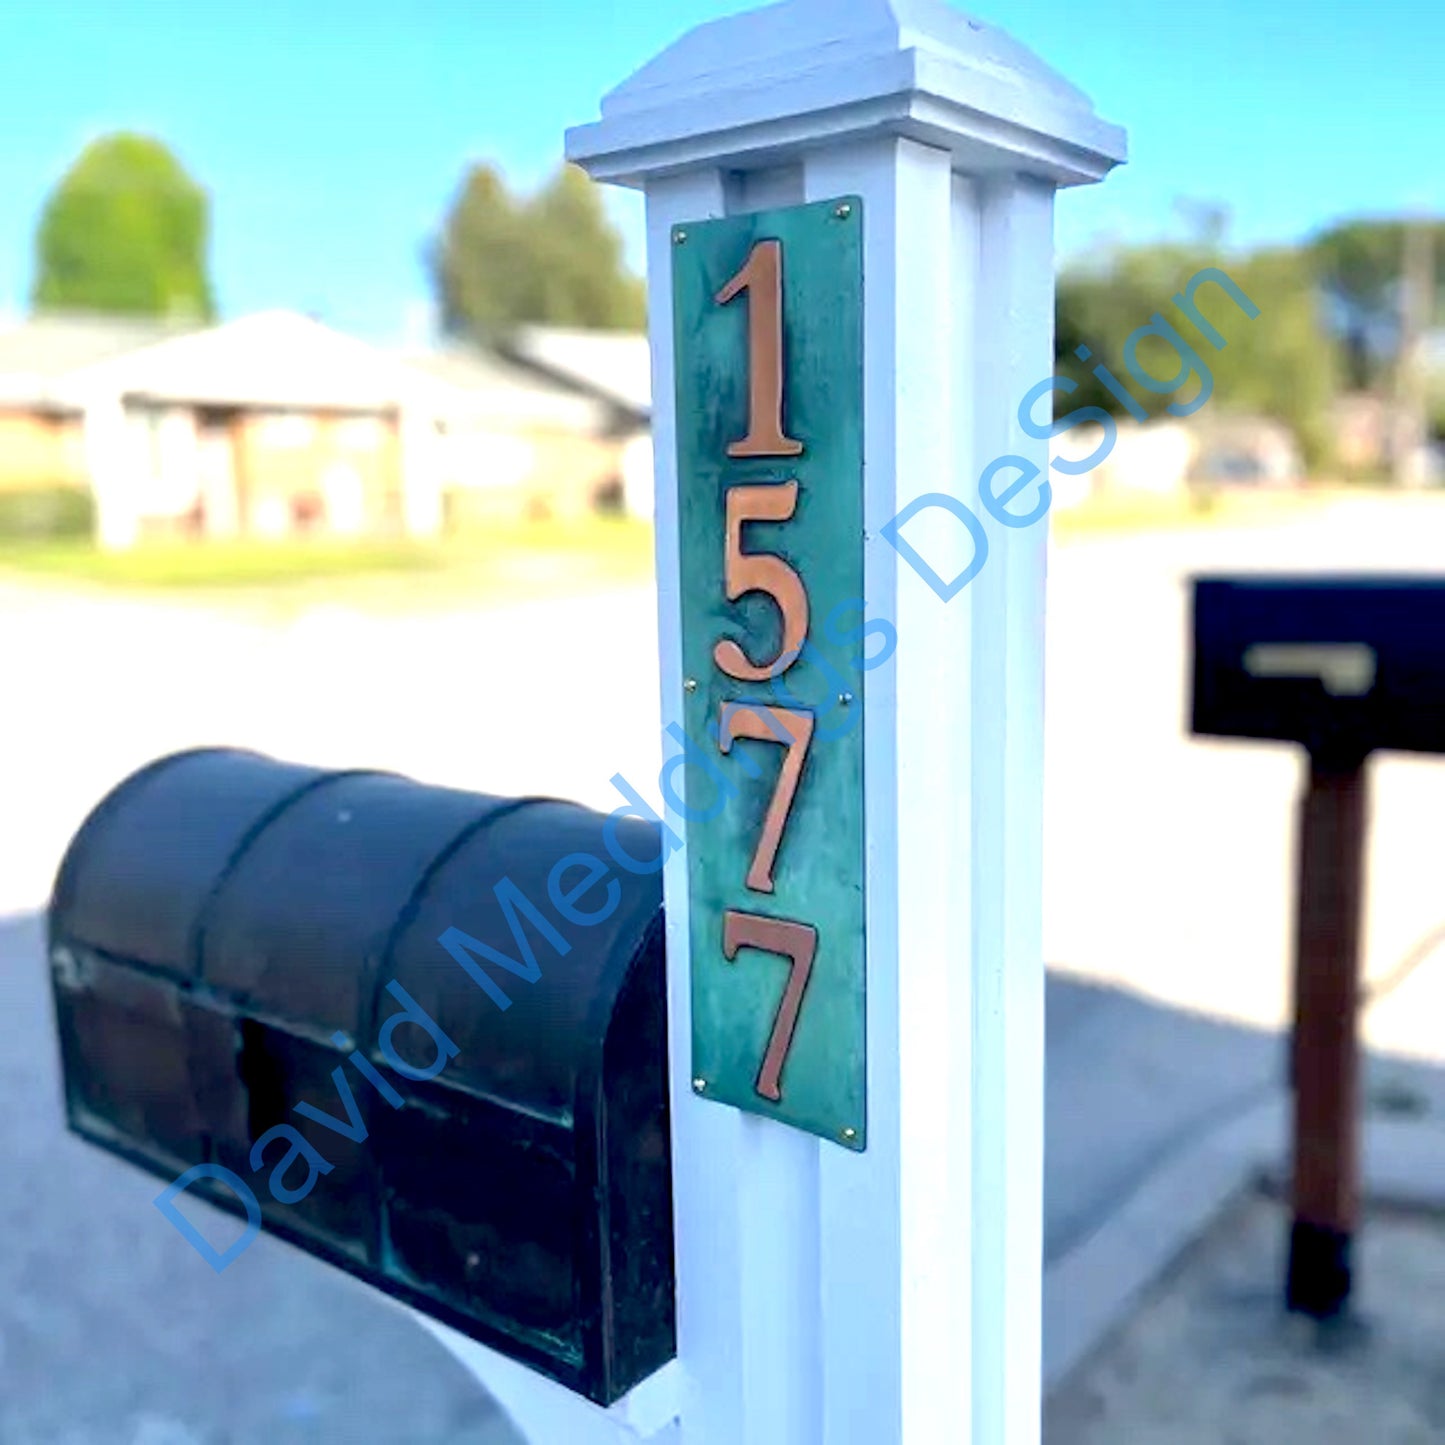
[8,501,1445,1445]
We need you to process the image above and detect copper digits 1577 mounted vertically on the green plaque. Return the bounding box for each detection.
[712,241,818,1104]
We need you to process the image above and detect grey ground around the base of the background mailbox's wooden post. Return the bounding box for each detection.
[1043,1198,1445,1445]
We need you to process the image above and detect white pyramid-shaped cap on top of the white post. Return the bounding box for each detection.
[568,0,1126,184]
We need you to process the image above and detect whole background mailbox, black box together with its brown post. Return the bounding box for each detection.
[1192,577,1445,1319]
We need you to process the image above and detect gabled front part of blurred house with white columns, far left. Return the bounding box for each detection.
[0,311,448,548]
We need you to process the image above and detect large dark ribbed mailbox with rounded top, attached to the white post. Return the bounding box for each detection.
[51,750,675,1405]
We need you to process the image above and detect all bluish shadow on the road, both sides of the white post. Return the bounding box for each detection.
[0,916,1445,1445]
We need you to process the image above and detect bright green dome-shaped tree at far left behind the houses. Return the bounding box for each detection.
[32,133,215,321]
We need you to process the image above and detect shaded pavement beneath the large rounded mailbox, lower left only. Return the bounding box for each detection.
[0,916,520,1445]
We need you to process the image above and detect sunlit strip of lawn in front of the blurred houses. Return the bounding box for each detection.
[0,517,653,610]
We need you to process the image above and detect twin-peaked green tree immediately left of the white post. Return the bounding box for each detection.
[428,165,646,340]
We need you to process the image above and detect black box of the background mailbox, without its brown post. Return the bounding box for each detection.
[1194,577,1445,760]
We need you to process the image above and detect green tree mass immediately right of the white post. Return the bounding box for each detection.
[1056,244,1338,464]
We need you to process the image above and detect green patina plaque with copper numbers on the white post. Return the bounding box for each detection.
[670,197,867,1150]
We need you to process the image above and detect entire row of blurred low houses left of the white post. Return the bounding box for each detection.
[0,311,652,548]
